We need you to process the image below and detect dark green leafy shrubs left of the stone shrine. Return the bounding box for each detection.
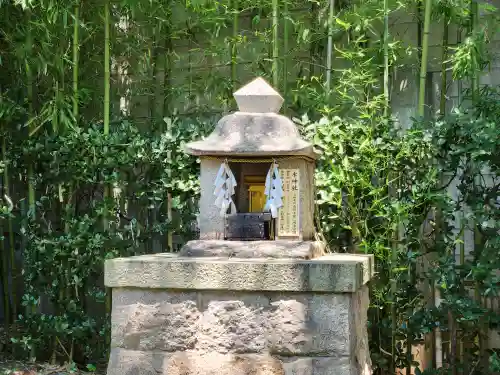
[3,118,208,358]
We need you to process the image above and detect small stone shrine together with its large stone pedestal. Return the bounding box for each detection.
[105,78,374,375]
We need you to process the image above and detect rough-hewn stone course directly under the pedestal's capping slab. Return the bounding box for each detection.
[112,289,368,356]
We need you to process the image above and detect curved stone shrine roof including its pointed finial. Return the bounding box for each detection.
[186,77,315,158]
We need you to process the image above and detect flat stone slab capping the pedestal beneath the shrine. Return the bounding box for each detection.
[104,253,374,293]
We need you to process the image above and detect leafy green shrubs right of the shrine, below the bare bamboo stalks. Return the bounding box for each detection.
[297,81,500,374]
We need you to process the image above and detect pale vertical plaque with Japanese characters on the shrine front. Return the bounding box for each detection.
[278,169,300,237]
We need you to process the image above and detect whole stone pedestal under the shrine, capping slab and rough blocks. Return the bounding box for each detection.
[105,250,373,375]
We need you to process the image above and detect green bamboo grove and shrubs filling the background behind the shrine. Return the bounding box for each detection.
[0,0,500,375]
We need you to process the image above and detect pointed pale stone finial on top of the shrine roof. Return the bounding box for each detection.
[233,77,284,113]
